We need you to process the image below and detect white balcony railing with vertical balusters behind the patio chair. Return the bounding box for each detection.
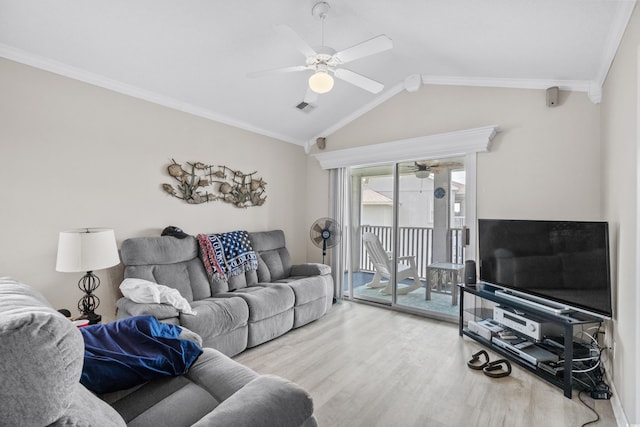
[359,225,464,279]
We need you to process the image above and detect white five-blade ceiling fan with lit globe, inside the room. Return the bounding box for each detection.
[247,1,393,102]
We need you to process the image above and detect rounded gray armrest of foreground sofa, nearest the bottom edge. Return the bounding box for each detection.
[194,375,313,427]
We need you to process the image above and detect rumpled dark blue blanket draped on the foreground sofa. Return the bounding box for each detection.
[80,316,202,393]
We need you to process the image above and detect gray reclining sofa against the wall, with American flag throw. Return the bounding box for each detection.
[117,230,333,356]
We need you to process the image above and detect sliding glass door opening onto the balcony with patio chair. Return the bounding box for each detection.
[345,158,465,319]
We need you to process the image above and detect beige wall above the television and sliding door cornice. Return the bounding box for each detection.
[314,86,602,220]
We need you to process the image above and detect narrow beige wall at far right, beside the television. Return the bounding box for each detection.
[602,3,640,425]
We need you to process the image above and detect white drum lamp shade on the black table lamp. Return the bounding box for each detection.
[56,228,120,272]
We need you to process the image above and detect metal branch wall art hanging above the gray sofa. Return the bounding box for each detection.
[162,159,267,208]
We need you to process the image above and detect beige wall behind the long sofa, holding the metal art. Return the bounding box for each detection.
[0,60,316,318]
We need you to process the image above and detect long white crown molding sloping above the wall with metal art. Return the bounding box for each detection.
[0,43,304,146]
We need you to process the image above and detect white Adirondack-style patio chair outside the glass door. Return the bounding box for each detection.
[362,233,422,295]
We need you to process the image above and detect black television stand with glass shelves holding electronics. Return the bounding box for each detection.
[458,283,602,398]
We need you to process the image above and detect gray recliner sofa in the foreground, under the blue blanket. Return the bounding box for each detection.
[0,279,317,427]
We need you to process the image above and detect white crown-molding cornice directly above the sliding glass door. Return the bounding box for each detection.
[313,125,498,169]
